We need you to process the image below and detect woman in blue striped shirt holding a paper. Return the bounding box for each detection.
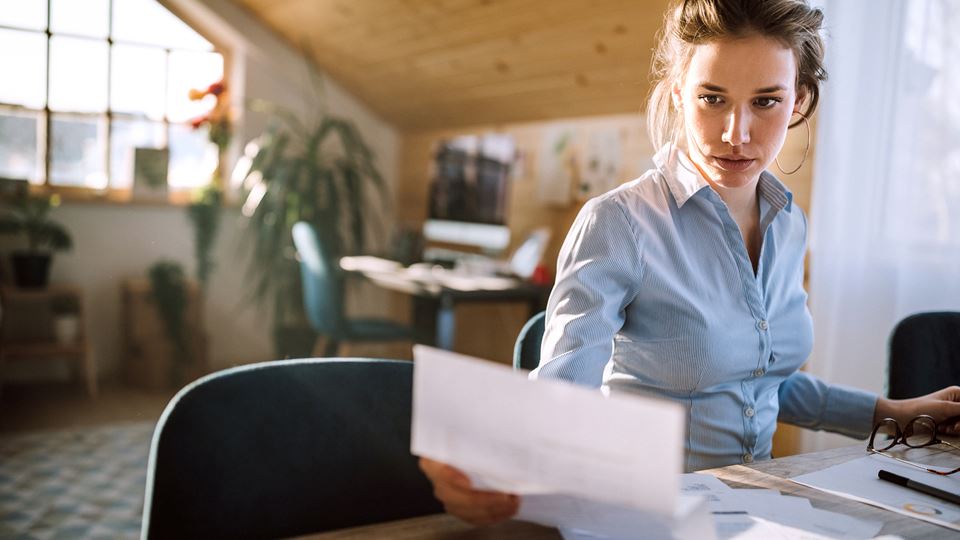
[421,0,960,524]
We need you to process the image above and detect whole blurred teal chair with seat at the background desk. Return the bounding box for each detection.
[293,221,414,356]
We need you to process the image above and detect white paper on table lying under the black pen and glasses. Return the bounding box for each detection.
[791,453,960,531]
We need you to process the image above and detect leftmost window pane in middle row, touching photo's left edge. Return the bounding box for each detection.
[0,29,47,109]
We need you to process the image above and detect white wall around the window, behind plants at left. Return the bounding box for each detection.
[5,0,400,377]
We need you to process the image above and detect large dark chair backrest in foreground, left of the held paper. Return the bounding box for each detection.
[142,358,443,538]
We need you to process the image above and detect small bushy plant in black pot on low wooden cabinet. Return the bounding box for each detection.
[0,190,73,288]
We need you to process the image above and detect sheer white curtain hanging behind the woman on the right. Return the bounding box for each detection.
[803,0,960,450]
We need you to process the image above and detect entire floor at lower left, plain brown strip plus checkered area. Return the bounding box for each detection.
[0,384,174,539]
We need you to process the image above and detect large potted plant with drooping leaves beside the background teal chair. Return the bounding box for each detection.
[234,99,389,358]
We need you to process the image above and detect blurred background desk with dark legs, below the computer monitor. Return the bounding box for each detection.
[340,257,550,350]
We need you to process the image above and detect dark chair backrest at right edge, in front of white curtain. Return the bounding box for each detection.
[887,312,960,399]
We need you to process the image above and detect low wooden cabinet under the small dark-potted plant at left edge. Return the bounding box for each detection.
[0,285,97,396]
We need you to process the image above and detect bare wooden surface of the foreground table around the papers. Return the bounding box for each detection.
[304,444,955,540]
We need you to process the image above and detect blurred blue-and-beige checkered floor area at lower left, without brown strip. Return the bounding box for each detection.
[0,422,154,540]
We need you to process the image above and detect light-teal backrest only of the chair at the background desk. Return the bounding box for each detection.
[293,221,343,336]
